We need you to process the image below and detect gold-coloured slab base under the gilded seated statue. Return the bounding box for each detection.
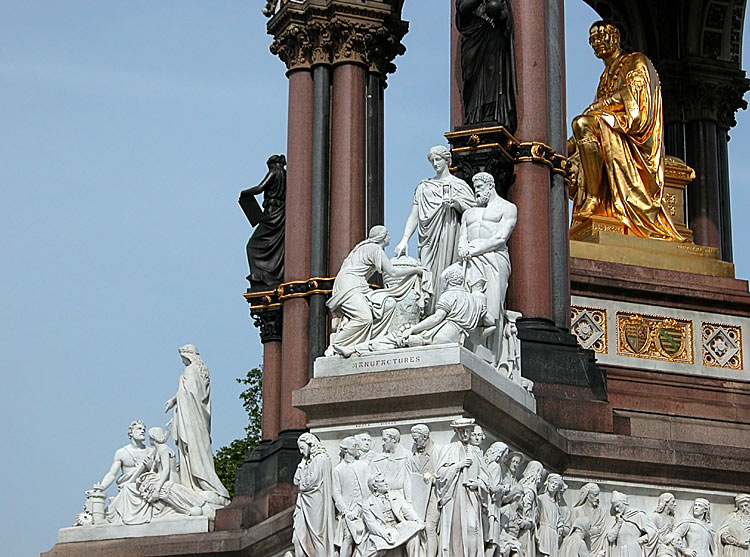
[570,229,734,278]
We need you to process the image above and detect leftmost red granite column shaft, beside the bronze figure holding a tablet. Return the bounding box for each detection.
[284,69,313,431]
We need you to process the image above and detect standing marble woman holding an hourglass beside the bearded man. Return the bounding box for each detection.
[395,145,474,315]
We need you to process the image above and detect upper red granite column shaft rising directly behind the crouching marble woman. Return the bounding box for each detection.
[329,63,366,273]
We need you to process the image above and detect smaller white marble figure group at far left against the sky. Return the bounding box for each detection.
[75,344,229,526]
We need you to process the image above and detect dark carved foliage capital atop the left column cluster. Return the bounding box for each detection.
[267,0,408,75]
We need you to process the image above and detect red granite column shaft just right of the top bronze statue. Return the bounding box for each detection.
[508,0,552,318]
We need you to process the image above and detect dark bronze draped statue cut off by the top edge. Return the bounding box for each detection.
[456,0,516,133]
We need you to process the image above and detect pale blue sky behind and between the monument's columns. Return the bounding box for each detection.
[0,0,750,555]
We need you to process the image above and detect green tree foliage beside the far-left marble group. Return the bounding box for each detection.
[214,368,263,496]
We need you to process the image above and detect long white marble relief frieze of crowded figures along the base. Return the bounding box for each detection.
[287,418,750,557]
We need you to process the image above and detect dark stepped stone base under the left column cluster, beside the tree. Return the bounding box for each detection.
[216,430,303,530]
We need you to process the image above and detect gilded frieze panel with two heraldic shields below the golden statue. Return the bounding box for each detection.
[616,311,694,364]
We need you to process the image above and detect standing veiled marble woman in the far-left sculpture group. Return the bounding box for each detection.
[164,344,229,506]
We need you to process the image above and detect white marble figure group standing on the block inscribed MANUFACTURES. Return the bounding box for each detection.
[326,146,521,383]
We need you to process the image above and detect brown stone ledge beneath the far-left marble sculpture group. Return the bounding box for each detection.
[42,509,293,557]
